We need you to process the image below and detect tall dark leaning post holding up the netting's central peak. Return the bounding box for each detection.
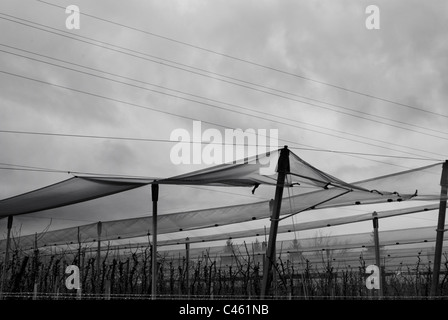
[261,146,290,298]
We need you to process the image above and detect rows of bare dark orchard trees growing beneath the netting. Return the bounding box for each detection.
[0,241,448,299]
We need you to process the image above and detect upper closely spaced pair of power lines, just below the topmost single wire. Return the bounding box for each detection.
[0,13,448,140]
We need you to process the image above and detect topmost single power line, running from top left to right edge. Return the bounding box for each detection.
[37,0,448,118]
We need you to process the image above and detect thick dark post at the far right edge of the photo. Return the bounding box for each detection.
[431,160,448,297]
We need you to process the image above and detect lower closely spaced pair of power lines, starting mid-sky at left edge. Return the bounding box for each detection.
[0,44,443,160]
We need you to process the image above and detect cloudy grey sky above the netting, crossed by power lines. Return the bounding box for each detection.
[0,0,448,245]
